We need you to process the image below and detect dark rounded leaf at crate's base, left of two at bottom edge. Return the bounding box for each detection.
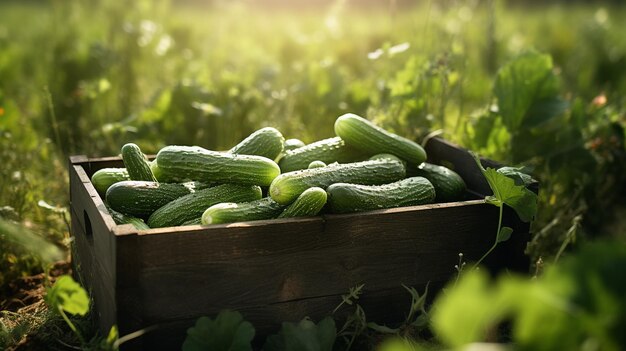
[182,310,255,351]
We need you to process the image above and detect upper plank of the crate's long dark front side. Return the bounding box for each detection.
[129,204,497,330]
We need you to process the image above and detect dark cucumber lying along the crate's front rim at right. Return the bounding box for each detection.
[326,177,435,213]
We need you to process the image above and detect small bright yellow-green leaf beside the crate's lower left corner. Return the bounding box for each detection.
[45,275,89,316]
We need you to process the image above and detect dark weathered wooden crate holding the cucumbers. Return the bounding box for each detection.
[69,138,536,349]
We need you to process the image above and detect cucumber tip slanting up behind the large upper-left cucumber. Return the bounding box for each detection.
[228,127,285,160]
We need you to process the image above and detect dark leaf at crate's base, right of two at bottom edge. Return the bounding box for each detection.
[263,317,337,351]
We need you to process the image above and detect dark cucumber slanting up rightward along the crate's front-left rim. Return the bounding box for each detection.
[148,184,261,228]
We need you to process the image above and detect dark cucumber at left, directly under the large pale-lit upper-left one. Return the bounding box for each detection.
[106,180,207,218]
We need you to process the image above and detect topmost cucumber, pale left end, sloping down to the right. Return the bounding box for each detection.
[335,113,426,164]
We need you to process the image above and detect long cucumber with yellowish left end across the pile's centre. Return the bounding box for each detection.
[269,159,406,205]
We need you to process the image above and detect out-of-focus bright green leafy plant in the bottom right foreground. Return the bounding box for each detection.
[432,242,626,350]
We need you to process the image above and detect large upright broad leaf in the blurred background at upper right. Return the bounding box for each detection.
[494,51,564,131]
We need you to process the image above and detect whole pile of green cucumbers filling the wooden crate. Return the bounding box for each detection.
[91,113,465,229]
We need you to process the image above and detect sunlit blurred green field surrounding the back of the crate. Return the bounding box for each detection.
[0,0,626,349]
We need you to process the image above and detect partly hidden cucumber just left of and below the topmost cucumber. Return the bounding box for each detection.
[278,137,368,173]
